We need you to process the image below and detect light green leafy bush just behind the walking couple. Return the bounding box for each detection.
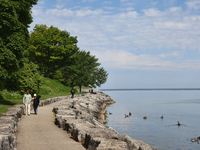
[7,62,42,94]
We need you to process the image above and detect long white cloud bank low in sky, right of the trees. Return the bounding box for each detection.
[92,51,200,71]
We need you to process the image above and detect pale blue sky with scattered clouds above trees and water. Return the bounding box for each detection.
[29,0,200,89]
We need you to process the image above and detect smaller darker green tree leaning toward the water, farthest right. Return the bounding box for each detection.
[62,51,108,91]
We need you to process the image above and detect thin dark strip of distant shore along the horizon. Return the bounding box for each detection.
[99,88,200,91]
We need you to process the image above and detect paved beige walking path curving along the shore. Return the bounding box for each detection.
[16,99,85,150]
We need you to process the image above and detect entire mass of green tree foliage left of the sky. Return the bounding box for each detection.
[0,0,108,93]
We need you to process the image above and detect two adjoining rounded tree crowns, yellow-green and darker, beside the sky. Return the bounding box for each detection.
[28,25,108,89]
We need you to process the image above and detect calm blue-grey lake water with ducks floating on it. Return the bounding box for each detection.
[101,90,200,150]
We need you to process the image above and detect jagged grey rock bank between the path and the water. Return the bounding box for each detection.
[53,92,156,150]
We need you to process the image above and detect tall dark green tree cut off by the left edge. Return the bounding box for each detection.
[0,0,38,89]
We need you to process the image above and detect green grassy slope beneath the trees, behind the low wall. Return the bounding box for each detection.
[0,78,84,114]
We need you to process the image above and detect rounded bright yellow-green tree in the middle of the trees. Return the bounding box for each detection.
[28,25,78,77]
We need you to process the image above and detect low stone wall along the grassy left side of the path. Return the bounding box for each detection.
[0,95,81,150]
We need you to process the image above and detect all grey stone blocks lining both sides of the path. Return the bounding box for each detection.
[0,91,156,150]
